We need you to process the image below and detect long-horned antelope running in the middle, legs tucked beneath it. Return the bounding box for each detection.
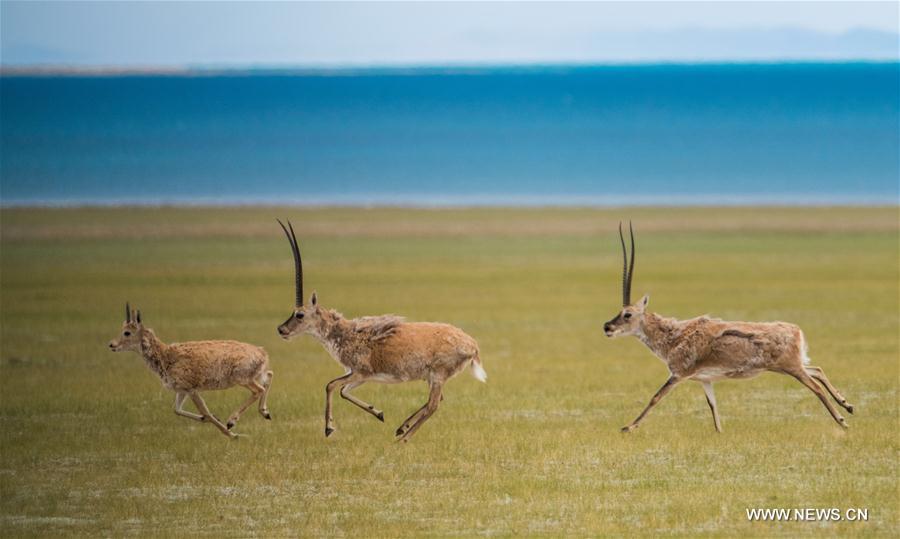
[278,220,487,442]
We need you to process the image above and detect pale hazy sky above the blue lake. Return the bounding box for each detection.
[0,0,900,67]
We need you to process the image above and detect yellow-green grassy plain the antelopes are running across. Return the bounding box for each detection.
[0,207,900,537]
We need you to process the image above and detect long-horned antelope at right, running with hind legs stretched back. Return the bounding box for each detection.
[603,223,853,432]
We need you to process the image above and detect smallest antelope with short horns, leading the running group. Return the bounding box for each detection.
[109,303,272,438]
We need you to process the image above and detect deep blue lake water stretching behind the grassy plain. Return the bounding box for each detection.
[0,63,900,205]
